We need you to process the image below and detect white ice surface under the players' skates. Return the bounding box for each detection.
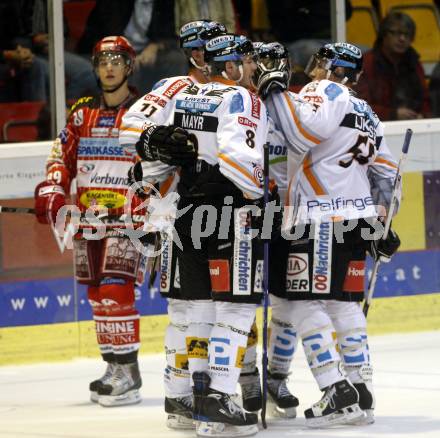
[0,331,440,438]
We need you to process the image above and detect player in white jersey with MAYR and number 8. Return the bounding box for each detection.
[132,34,267,436]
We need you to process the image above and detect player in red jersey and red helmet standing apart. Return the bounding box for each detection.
[35,36,142,406]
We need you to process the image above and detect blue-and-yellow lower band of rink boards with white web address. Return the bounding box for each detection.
[0,250,440,365]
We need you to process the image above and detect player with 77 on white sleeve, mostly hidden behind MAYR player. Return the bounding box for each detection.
[120,20,226,429]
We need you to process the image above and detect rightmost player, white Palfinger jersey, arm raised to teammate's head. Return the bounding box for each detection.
[258,43,399,427]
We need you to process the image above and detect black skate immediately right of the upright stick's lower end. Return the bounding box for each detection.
[267,373,299,418]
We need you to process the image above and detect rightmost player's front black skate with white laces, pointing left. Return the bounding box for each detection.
[304,380,365,428]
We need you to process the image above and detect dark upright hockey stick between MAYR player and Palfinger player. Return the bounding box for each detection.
[261,143,269,429]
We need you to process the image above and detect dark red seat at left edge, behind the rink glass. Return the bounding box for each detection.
[0,102,46,142]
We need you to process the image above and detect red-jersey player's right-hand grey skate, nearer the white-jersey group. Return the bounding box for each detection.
[98,362,142,407]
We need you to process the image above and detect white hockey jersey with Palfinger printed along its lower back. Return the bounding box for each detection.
[266,80,397,223]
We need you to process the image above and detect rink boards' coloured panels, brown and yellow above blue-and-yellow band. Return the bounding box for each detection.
[0,171,440,364]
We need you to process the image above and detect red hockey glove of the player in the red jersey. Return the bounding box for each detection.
[35,181,66,224]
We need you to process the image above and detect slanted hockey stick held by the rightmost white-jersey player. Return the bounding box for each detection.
[363,129,412,316]
